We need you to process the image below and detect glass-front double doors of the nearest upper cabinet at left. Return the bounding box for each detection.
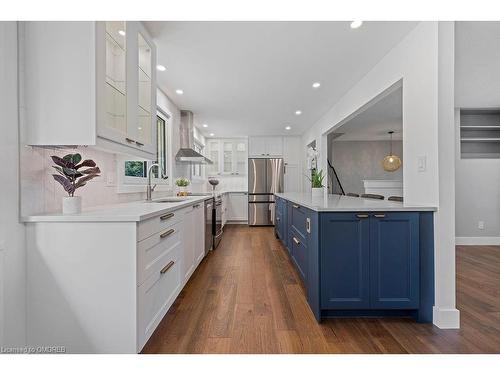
[96,21,157,159]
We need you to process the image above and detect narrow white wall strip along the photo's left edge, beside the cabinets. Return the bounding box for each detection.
[0,22,26,347]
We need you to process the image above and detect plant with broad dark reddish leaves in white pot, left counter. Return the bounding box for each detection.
[51,154,101,214]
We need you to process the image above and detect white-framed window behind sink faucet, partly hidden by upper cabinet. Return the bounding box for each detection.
[117,108,170,192]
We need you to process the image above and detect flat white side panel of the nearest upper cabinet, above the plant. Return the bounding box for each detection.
[23,21,96,146]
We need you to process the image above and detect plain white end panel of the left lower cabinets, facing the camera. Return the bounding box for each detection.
[27,222,137,353]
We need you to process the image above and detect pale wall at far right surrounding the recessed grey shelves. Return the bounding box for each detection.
[455,22,500,245]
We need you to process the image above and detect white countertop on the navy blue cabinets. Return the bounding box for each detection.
[275,193,437,212]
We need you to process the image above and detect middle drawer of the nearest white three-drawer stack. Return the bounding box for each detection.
[137,222,182,285]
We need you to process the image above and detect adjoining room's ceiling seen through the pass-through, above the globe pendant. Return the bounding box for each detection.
[335,88,403,141]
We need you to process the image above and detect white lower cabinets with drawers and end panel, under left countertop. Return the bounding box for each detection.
[27,202,205,353]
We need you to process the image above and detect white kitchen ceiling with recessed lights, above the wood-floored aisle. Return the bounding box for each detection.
[145,21,416,137]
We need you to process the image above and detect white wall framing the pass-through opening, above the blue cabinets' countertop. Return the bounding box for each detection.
[303,22,439,206]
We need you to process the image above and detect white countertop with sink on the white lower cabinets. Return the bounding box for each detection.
[21,194,212,223]
